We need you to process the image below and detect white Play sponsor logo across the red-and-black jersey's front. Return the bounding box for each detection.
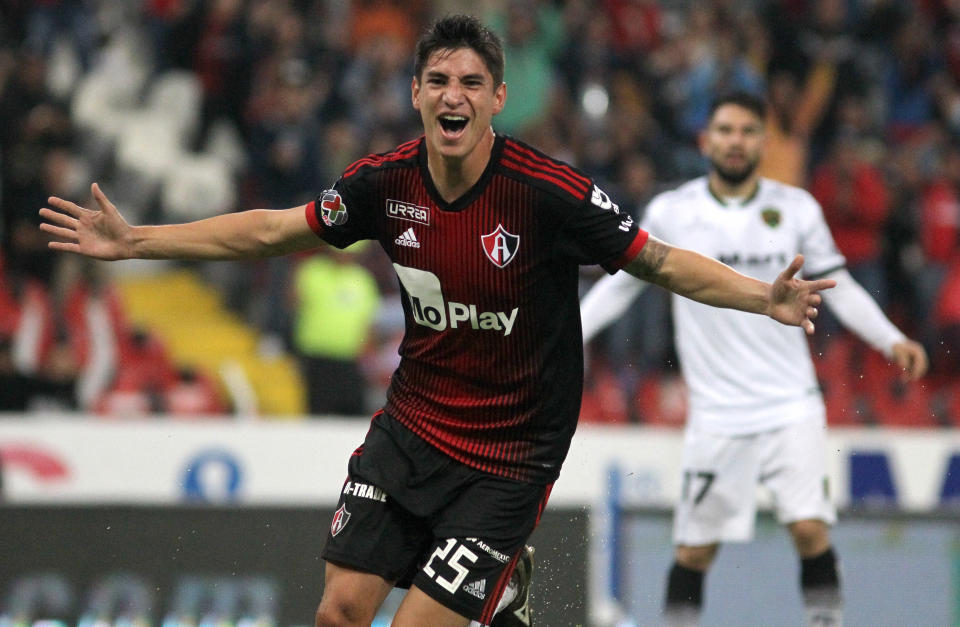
[393,263,520,337]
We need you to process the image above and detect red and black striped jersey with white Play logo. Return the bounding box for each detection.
[307,136,647,482]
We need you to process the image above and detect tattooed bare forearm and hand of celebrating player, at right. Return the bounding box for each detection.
[624,237,836,334]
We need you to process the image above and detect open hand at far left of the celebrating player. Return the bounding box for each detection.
[40,183,132,260]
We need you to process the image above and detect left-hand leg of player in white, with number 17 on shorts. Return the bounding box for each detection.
[663,429,757,627]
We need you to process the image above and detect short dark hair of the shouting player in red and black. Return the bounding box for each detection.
[413,15,503,89]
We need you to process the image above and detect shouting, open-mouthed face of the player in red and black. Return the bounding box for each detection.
[412,48,507,159]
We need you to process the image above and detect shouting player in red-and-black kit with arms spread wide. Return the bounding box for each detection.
[40,16,833,627]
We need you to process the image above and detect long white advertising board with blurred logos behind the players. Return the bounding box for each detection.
[0,415,960,512]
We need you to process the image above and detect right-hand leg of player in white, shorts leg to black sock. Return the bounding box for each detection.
[764,419,843,626]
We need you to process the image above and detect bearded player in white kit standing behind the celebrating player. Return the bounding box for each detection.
[581,94,928,625]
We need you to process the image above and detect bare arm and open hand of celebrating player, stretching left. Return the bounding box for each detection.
[40,183,323,260]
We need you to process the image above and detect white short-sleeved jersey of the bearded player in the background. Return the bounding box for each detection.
[641,177,846,435]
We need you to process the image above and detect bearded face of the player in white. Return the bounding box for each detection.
[700,104,764,185]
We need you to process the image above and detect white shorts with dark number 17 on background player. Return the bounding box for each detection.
[673,420,837,546]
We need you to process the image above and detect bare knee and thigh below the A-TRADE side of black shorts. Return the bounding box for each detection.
[316,562,393,627]
